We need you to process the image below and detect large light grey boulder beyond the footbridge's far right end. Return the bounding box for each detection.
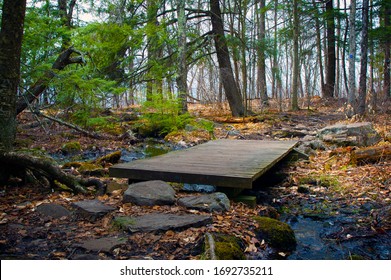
[318,122,381,147]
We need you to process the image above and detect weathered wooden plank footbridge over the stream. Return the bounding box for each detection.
[110,139,297,188]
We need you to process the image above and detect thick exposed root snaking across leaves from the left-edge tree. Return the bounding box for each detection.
[0,152,104,194]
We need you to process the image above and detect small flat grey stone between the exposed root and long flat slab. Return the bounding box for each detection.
[72,199,115,222]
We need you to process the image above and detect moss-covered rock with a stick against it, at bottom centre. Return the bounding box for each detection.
[203,234,246,260]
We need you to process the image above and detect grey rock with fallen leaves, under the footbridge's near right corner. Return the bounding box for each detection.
[178,192,230,212]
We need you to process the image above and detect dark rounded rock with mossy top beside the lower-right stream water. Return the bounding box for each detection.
[254,217,296,252]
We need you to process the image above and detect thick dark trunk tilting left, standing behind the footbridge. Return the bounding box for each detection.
[210,0,244,117]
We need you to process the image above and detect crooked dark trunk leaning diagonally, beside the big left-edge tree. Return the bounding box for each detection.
[16,47,86,114]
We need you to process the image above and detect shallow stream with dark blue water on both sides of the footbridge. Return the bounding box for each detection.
[51,140,391,260]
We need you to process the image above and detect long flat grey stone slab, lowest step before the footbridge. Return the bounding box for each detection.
[114,213,212,233]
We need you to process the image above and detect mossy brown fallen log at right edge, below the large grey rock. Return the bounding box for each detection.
[350,145,391,164]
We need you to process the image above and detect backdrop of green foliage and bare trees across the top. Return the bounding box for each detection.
[0,0,391,122]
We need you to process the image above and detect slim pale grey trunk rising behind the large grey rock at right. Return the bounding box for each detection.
[346,0,356,118]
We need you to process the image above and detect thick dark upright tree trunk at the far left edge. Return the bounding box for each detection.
[0,0,26,152]
